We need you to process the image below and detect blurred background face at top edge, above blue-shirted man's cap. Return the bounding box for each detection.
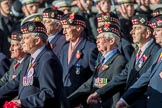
[99,0,110,12]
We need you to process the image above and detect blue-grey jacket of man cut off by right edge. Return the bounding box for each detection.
[122,49,162,108]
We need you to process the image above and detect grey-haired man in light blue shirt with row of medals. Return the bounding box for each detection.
[68,24,126,108]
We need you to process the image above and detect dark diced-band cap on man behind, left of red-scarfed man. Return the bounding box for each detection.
[42,6,64,20]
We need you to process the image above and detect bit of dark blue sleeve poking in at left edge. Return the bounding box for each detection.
[0,53,11,78]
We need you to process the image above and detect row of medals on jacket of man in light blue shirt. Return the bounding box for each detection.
[94,77,108,88]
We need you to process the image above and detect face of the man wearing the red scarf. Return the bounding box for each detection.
[63,25,78,41]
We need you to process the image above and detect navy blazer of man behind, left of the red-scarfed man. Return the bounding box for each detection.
[50,32,66,57]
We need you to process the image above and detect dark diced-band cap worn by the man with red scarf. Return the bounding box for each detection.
[61,13,86,28]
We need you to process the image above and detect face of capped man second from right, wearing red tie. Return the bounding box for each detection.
[130,25,147,44]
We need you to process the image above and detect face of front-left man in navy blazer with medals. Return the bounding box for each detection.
[21,33,36,54]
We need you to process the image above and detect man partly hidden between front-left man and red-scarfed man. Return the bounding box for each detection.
[42,7,66,57]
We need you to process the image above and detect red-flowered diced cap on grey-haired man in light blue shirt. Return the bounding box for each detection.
[97,23,120,37]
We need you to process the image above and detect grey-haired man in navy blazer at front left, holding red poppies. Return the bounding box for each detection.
[0,21,63,108]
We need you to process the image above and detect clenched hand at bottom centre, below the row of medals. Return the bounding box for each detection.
[87,92,101,104]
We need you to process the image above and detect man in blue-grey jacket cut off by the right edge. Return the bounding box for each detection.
[116,16,162,108]
